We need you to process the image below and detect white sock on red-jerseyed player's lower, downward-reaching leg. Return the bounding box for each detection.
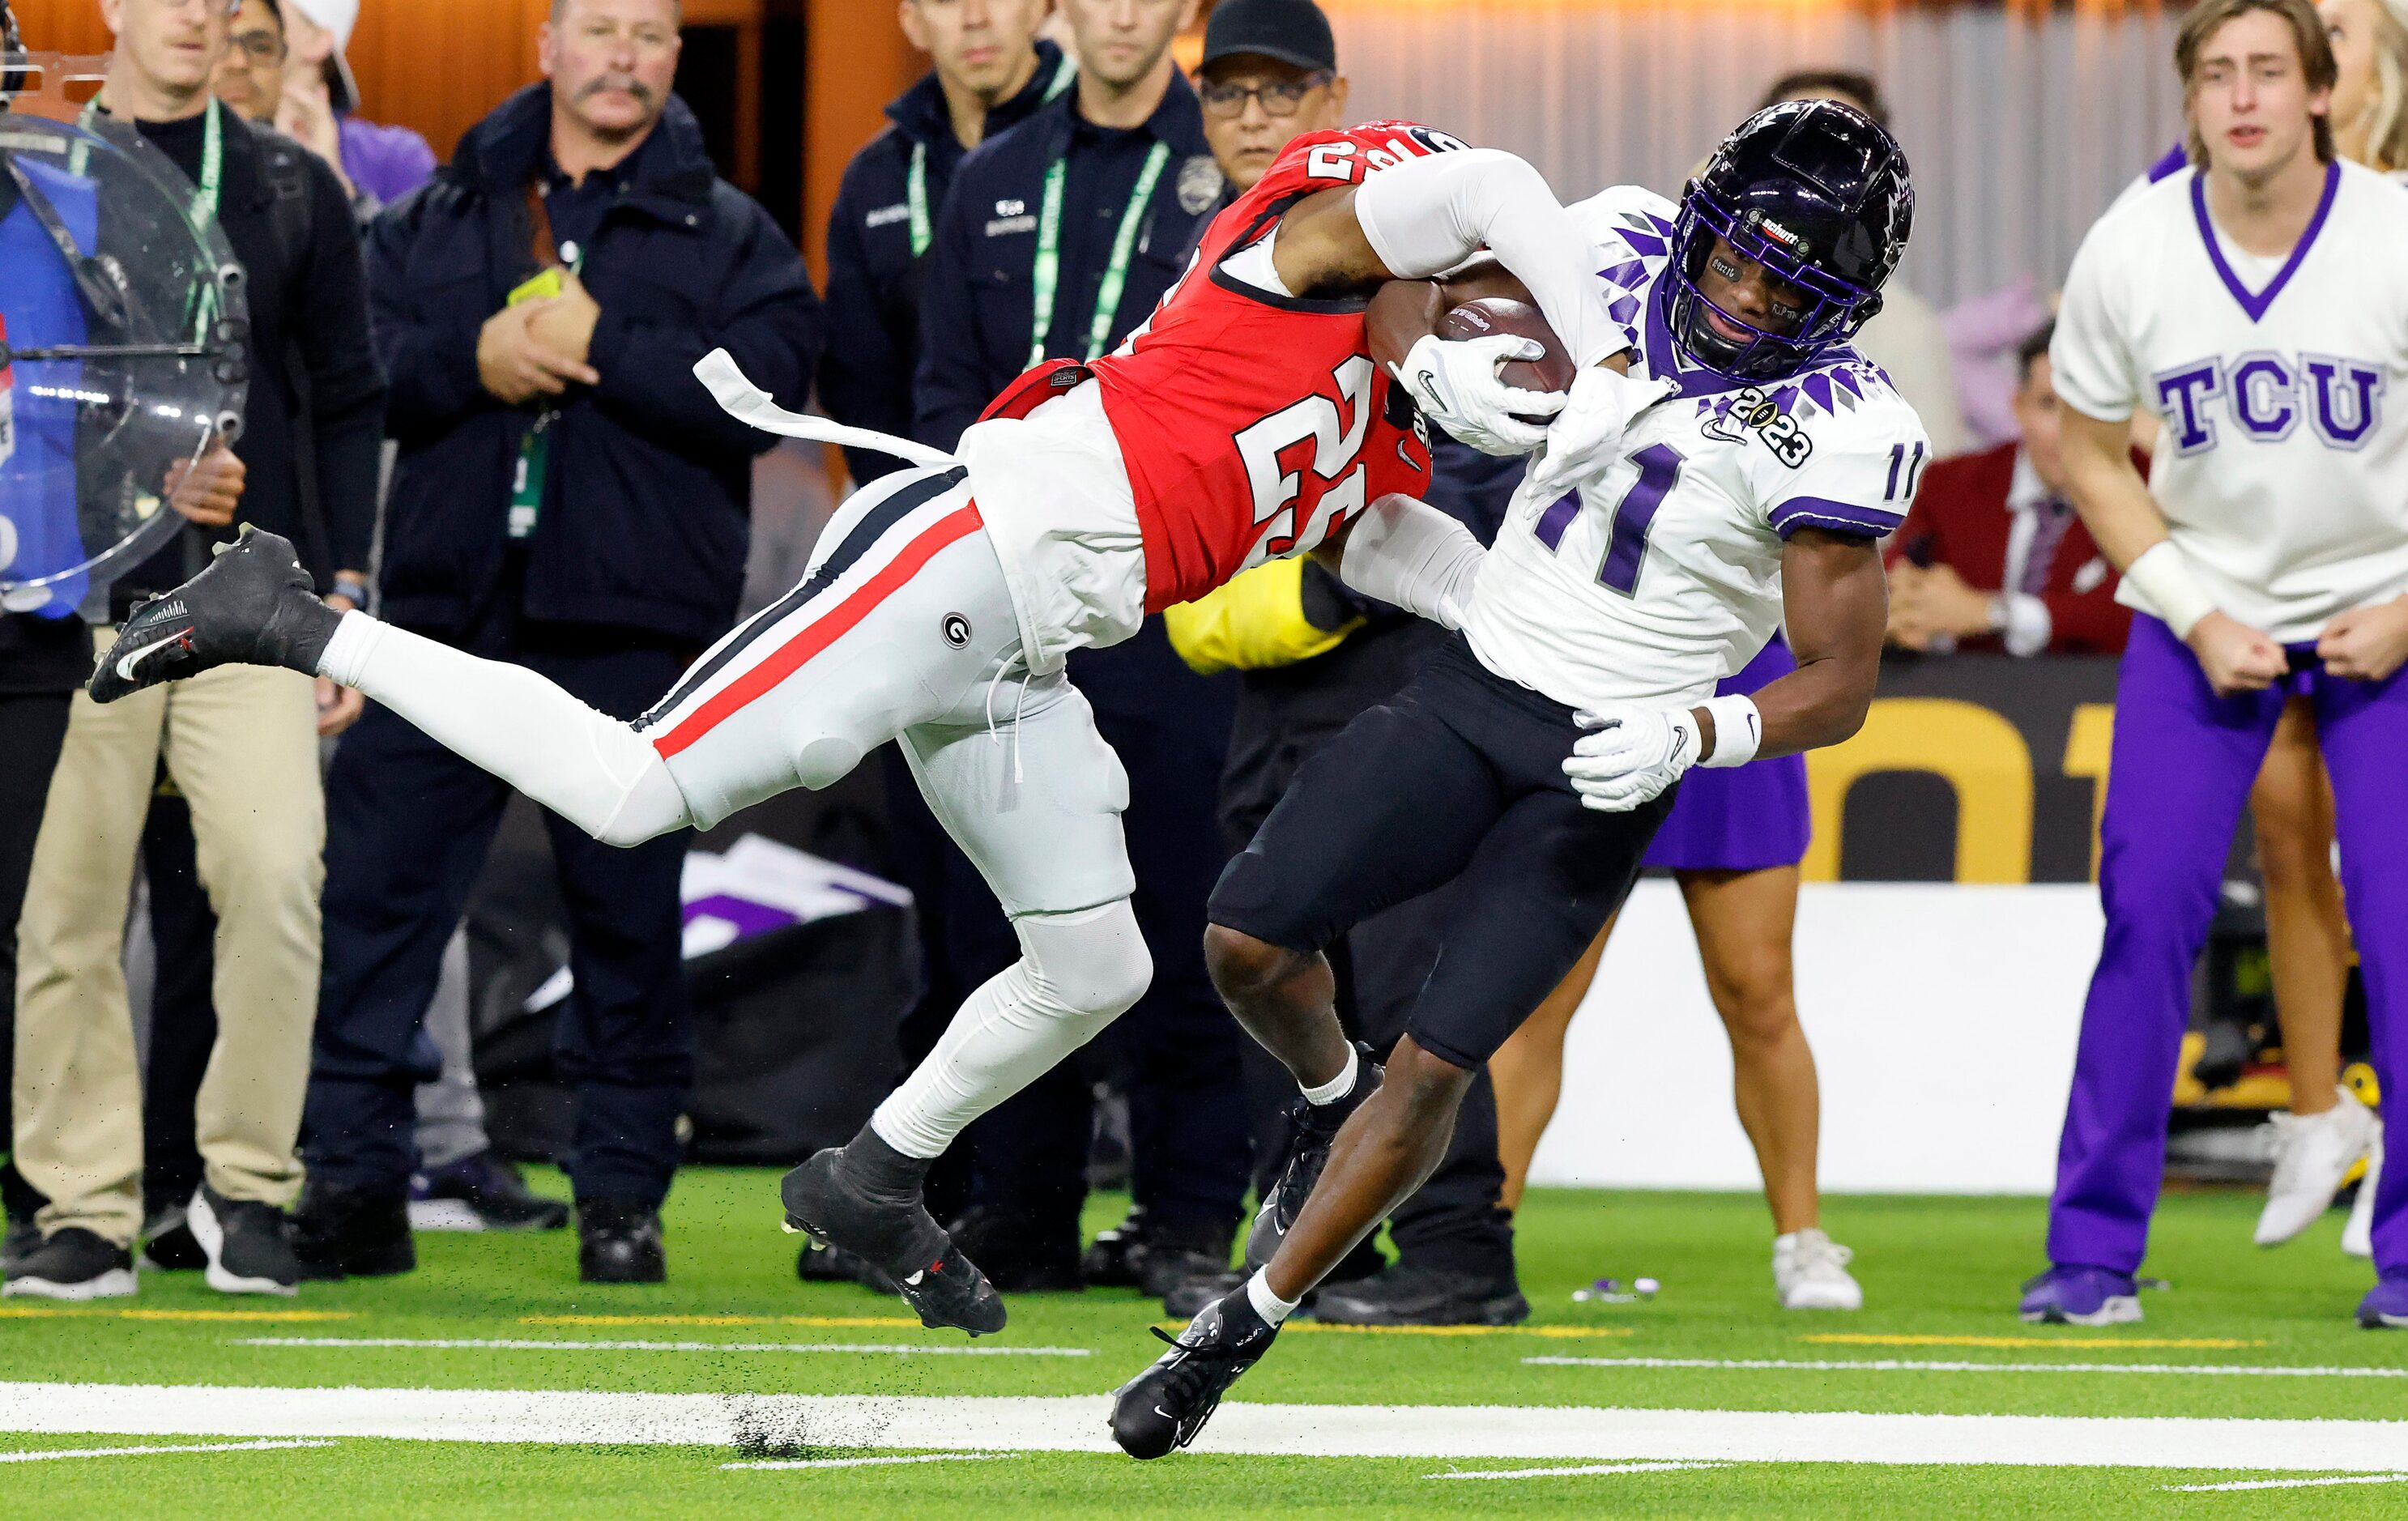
[869,897,1153,1157]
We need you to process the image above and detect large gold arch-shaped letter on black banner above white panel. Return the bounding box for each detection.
[1801,698,2032,884]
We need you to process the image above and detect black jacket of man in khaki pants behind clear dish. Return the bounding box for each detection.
[118,111,386,611]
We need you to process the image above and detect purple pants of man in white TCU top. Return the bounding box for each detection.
[2049,616,2408,1276]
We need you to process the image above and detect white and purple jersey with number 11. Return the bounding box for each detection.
[1464,185,1931,708]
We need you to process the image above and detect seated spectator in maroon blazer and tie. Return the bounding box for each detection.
[1888,322,2131,654]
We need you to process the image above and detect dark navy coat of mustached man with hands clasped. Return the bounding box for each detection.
[369,84,824,640]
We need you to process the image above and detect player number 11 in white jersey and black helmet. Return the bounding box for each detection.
[1113,101,1929,1459]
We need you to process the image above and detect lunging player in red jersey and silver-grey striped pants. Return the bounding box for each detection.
[92,123,1659,1336]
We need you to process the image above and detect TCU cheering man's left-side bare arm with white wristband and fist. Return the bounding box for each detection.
[2061,407,2290,696]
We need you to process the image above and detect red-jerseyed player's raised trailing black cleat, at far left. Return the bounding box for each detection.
[92,525,342,703]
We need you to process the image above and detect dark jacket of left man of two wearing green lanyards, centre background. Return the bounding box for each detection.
[819,41,1074,484]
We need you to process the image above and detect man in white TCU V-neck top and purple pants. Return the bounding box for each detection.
[2022,0,2408,1326]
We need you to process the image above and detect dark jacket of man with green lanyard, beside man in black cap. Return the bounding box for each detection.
[913,75,1223,448]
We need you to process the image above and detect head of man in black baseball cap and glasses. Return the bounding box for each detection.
[1197,0,1346,195]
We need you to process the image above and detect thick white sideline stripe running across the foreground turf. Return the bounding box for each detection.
[0,1384,2408,1473]
